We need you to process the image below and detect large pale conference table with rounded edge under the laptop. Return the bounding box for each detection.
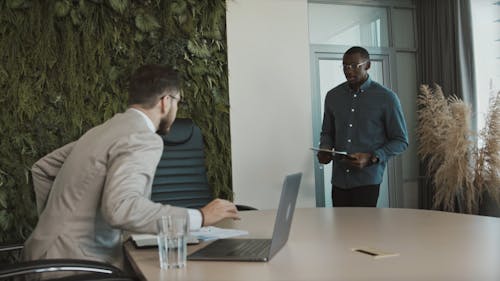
[125,208,500,281]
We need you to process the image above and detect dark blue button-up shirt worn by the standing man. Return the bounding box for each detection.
[320,77,408,188]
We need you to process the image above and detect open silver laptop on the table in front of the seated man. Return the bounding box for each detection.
[187,173,302,262]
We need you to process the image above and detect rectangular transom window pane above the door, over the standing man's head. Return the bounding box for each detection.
[308,3,389,47]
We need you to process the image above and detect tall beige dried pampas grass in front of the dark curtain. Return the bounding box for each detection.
[417,85,500,213]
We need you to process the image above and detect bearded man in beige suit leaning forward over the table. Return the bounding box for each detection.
[24,65,239,268]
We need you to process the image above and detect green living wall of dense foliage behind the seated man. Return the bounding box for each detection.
[0,0,232,243]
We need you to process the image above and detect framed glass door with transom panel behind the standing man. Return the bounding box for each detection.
[308,0,419,207]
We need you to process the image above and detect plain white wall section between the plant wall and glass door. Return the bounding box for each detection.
[226,0,316,209]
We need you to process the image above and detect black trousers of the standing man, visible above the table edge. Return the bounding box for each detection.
[332,184,380,207]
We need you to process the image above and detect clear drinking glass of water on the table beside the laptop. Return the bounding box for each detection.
[157,215,188,269]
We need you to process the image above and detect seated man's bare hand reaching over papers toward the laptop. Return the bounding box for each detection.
[200,199,240,226]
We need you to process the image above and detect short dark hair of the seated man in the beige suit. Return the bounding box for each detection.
[128,64,180,108]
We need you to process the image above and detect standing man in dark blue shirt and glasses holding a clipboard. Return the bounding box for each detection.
[317,47,408,207]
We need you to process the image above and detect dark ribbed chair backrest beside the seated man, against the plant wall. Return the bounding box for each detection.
[151,118,212,208]
